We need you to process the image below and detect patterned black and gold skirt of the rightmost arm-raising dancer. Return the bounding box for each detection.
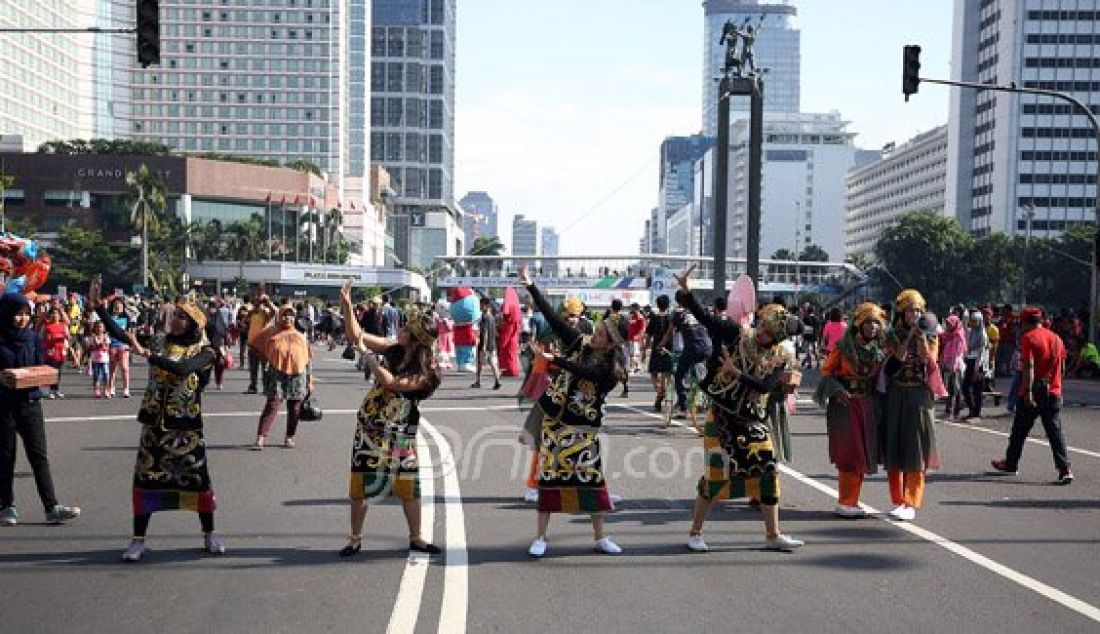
[696,408,779,505]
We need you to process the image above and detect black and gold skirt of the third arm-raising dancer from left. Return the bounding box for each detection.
[539,417,615,514]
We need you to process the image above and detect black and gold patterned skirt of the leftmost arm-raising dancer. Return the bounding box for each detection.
[133,425,217,515]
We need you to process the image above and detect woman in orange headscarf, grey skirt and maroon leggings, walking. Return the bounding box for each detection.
[252,306,314,451]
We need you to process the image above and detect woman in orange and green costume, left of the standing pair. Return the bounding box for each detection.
[814,302,886,517]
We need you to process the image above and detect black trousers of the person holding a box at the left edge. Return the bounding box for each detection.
[0,398,57,512]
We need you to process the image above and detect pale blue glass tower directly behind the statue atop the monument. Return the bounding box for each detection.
[702,0,802,136]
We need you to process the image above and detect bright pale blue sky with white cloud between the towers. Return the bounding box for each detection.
[455,0,954,254]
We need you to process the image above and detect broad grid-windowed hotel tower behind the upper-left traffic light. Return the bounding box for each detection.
[131,0,369,190]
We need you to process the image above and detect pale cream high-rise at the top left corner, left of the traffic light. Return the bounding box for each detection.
[0,0,136,150]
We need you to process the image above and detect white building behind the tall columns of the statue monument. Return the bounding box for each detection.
[726,112,879,261]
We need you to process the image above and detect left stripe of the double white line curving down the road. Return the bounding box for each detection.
[386,433,436,634]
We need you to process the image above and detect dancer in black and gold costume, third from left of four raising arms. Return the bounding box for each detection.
[519,267,626,557]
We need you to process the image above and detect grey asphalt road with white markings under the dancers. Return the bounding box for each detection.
[0,352,1100,633]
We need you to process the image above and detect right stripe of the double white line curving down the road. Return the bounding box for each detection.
[420,417,470,634]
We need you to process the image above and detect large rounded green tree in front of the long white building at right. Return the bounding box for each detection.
[871,211,974,311]
